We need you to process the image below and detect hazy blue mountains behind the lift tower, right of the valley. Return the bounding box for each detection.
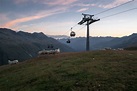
[58,33,137,51]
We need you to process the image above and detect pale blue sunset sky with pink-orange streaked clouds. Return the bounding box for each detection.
[0,0,137,37]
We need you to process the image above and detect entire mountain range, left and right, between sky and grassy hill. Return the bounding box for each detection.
[0,28,137,65]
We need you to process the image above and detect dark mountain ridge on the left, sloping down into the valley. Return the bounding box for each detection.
[0,28,74,65]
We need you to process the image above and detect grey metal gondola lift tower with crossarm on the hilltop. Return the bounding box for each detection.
[78,13,100,51]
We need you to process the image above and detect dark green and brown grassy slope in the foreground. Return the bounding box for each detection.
[0,51,137,91]
